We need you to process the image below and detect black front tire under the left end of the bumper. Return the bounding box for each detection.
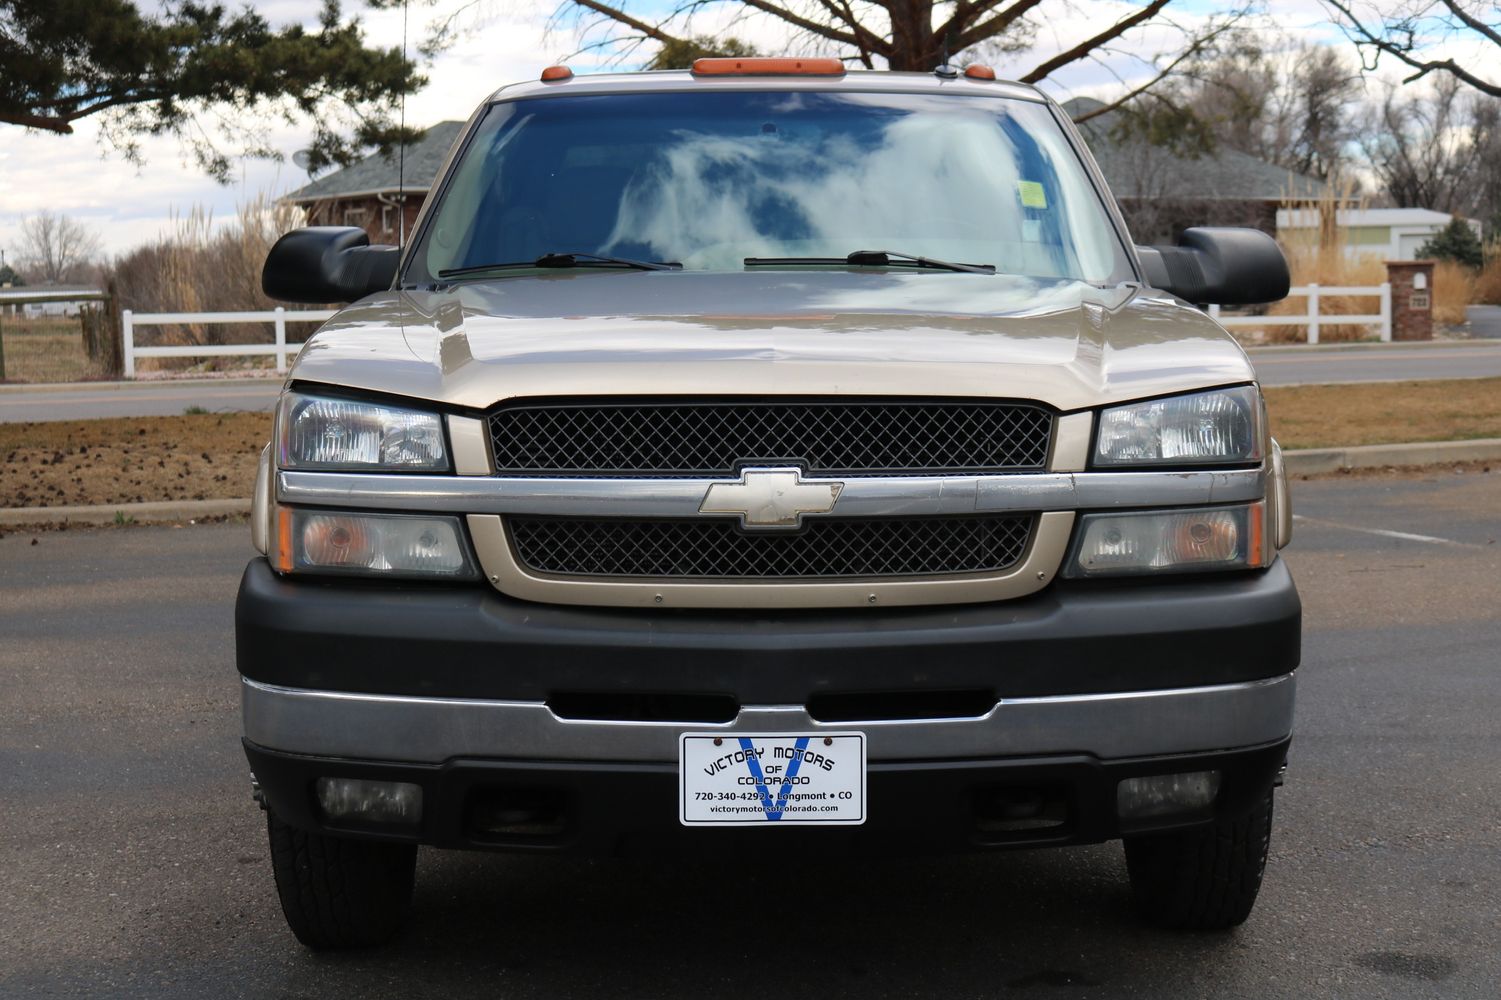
[266,811,417,950]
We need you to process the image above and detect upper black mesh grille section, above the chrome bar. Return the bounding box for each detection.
[489,399,1052,476]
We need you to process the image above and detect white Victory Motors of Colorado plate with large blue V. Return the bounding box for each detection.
[677,733,865,826]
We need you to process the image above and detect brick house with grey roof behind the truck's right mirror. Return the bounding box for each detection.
[1063,98,1331,245]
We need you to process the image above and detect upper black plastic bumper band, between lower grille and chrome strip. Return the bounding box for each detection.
[236,559,1301,704]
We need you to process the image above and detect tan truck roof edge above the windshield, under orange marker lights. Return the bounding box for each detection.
[486,69,1048,104]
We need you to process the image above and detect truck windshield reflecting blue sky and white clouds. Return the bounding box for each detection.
[408,90,1126,282]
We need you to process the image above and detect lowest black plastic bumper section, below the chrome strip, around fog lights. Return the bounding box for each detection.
[245,740,1288,854]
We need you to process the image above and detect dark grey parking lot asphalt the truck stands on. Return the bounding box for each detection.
[0,470,1501,1000]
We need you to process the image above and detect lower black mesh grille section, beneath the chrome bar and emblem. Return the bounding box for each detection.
[507,514,1033,580]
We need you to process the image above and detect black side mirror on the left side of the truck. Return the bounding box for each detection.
[261,225,401,303]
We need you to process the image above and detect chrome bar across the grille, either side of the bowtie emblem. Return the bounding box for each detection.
[276,467,1265,518]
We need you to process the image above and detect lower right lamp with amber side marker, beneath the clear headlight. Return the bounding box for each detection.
[1064,500,1267,577]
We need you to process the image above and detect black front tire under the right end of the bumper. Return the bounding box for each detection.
[1126,791,1271,931]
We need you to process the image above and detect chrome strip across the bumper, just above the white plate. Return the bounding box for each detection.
[242,674,1297,764]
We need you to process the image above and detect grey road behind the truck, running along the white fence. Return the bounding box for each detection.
[0,336,1501,423]
